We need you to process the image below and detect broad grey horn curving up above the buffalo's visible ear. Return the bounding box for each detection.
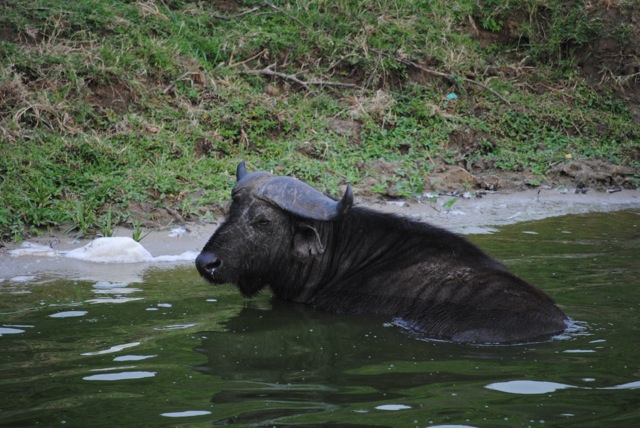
[257,177,353,221]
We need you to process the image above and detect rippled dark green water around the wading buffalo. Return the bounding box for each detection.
[0,210,640,427]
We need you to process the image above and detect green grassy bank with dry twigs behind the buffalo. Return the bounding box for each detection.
[0,0,640,239]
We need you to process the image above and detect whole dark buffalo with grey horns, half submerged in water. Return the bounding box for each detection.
[196,162,567,343]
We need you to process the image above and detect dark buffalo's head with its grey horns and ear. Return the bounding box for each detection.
[196,162,353,296]
